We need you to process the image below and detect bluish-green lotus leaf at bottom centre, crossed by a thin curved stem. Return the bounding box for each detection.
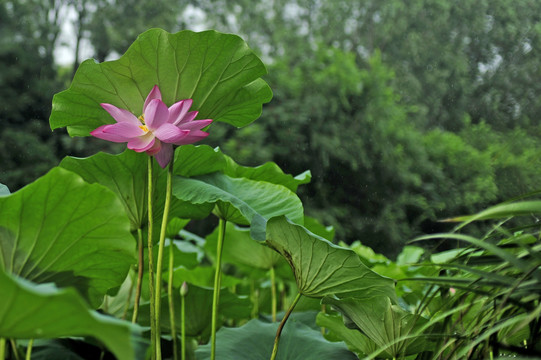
[195,319,357,360]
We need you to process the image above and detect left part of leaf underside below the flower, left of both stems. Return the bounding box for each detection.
[60,150,148,231]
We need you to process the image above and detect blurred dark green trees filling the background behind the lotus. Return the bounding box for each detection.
[0,0,541,256]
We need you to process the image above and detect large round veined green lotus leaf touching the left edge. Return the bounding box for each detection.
[0,168,136,307]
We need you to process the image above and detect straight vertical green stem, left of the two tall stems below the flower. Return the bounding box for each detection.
[147,156,156,360]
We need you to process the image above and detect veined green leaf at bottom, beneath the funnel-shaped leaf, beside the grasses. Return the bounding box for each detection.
[322,296,432,358]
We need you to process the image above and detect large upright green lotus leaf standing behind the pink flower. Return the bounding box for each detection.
[50,29,272,136]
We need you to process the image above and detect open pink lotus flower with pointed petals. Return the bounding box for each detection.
[90,85,212,168]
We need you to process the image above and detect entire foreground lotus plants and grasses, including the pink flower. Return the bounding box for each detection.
[0,29,541,360]
